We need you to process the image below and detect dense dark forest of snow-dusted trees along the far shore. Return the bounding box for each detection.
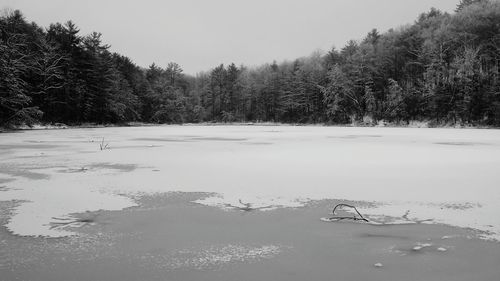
[0,0,500,126]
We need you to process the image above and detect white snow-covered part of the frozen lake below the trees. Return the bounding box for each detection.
[0,126,500,239]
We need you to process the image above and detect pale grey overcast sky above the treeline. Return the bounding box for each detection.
[0,0,459,74]
